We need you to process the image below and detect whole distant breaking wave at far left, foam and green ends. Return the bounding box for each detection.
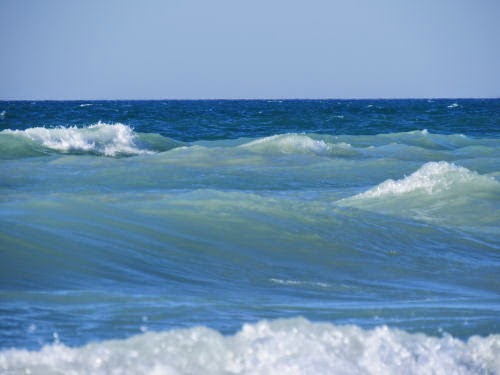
[0,122,181,157]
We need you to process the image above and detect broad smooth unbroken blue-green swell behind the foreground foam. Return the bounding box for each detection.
[0,189,498,299]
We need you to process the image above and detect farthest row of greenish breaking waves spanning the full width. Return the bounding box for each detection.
[0,127,498,160]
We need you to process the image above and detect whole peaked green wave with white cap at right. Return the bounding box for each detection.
[339,161,500,226]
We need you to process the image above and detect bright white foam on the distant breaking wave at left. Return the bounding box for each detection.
[6,122,150,156]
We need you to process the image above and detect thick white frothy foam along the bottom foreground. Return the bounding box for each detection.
[0,318,500,375]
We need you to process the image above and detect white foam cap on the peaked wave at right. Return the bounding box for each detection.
[356,161,486,198]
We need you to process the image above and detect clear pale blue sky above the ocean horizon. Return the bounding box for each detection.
[0,0,500,100]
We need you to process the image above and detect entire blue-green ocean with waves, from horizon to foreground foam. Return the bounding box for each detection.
[0,99,500,375]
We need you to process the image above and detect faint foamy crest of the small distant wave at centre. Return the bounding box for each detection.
[239,134,353,155]
